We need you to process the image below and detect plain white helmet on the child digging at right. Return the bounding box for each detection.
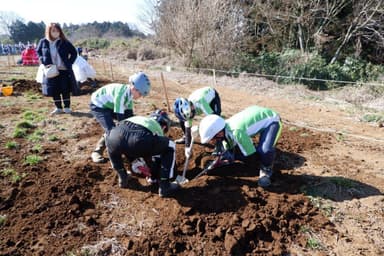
[199,115,225,144]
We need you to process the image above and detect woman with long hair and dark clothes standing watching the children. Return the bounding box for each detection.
[37,23,77,115]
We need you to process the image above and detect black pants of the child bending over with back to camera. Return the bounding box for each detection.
[106,121,175,179]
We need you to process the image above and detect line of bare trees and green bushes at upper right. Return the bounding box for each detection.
[152,0,384,87]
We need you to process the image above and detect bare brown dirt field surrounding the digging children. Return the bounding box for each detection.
[0,65,384,255]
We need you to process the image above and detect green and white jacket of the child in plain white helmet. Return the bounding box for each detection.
[224,106,280,156]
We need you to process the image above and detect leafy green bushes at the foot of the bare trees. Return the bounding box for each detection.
[235,49,384,90]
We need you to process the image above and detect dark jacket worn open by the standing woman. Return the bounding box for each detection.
[37,38,77,70]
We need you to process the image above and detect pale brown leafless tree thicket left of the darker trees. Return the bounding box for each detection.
[155,0,243,68]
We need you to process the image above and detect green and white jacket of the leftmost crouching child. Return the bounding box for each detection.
[91,83,133,114]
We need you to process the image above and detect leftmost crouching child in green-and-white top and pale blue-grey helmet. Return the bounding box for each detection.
[90,72,151,163]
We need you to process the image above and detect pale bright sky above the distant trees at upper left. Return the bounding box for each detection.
[0,0,154,32]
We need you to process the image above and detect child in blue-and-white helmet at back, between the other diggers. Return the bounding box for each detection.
[173,86,221,158]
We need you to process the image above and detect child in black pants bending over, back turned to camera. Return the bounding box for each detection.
[106,110,179,197]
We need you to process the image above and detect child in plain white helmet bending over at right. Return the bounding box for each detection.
[199,106,282,187]
